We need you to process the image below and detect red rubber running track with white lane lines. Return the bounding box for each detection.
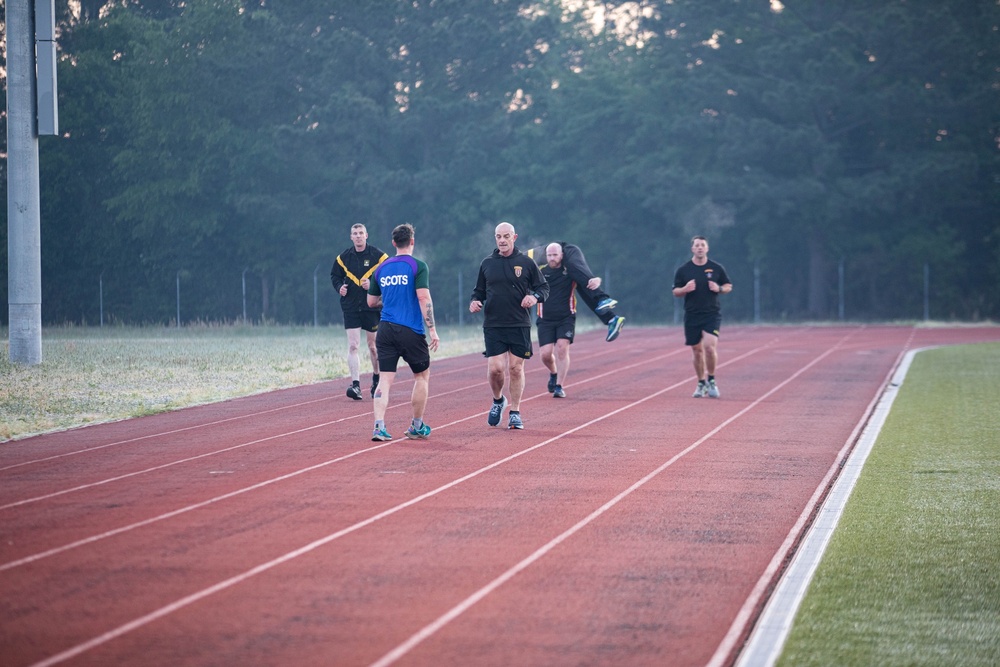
[0,326,1000,667]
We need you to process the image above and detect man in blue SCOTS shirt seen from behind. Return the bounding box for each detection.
[368,224,441,441]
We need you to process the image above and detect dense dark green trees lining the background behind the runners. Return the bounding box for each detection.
[0,0,1000,324]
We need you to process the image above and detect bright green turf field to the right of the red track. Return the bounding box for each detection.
[778,344,1000,667]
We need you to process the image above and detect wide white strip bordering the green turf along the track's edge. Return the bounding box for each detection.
[728,346,934,667]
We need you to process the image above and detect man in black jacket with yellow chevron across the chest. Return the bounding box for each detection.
[330,223,389,401]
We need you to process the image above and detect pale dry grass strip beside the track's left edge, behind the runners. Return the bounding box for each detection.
[0,326,483,441]
